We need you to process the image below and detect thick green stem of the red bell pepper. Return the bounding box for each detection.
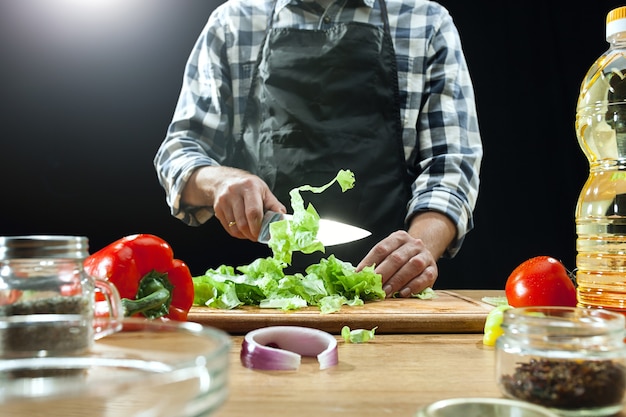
[122,271,174,319]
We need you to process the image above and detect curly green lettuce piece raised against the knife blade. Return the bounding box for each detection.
[267,170,355,264]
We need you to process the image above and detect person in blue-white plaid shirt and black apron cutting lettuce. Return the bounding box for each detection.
[154,0,483,297]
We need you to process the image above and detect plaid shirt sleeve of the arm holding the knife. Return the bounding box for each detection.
[153,14,233,226]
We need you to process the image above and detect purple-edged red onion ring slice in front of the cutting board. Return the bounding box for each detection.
[240,326,339,370]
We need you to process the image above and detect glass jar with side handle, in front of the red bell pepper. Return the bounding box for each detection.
[0,236,123,359]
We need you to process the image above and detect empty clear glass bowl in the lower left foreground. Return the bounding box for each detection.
[0,319,231,417]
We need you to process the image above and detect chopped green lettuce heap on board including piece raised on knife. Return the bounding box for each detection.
[193,170,385,314]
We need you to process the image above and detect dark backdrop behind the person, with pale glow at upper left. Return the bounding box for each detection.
[0,0,620,289]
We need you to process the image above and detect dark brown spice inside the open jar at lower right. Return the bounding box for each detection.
[500,359,626,409]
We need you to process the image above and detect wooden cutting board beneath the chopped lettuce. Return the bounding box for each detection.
[188,291,493,334]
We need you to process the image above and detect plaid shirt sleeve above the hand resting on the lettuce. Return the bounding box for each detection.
[407,9,483,257]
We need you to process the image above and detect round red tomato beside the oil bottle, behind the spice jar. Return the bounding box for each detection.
[504,256,577,307]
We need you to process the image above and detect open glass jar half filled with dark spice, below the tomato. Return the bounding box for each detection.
[496,307,626,417]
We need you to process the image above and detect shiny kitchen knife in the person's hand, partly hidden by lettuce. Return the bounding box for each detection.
[257,211,372,246]
